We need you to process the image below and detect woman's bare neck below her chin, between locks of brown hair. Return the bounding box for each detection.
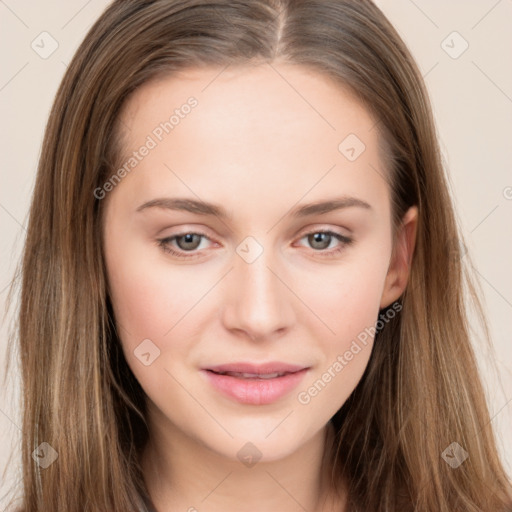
[142,414,344,512]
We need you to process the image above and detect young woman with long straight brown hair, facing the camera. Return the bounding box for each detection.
[5,0,512,512]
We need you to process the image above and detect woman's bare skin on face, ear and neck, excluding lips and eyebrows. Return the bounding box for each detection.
[103,63,417,512]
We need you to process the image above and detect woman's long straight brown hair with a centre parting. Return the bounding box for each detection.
[5,0,512,512]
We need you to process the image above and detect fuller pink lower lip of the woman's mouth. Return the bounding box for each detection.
[203,368,308,405]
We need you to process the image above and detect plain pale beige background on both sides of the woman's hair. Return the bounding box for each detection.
[0,0,512,504]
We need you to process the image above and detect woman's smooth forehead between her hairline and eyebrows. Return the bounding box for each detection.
[112,63,385,218]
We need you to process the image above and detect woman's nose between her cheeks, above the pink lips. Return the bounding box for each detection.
[222,242,295,340]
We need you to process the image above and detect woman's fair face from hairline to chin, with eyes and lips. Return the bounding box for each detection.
[102,64,414,460]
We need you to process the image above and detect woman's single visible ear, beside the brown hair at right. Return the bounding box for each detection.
[380,206,418,309]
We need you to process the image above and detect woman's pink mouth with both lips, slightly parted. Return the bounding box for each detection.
[202,363,309,405]
